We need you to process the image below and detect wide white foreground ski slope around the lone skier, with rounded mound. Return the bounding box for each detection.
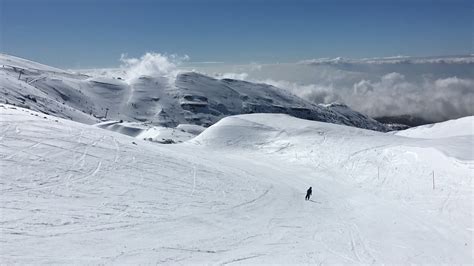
[0,105,474,264]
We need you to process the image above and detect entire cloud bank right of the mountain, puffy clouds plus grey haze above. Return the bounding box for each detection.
[195,55,474,121]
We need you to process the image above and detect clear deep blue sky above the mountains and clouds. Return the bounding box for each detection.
[0,0,473,68]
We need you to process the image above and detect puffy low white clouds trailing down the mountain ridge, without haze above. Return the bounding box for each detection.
[218,72,474,121]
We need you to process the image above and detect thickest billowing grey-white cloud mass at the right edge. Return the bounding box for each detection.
[340,73,474,121]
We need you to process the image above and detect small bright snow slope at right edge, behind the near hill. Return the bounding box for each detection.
[396,116,474,139]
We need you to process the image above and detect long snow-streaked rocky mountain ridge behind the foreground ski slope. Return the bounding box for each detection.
[0,54,389,131]
